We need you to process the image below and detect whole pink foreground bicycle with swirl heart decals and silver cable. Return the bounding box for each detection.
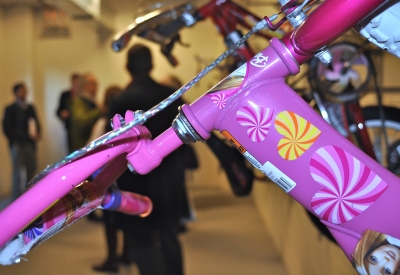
[0,0,400,274]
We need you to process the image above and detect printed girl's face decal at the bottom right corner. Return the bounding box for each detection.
[353,230,400,275]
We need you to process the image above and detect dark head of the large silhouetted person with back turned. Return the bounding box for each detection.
[126,44,153,76]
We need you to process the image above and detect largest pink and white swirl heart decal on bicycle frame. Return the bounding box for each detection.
[310,146,388,224]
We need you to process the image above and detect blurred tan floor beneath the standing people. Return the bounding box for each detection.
[0,189,287,275]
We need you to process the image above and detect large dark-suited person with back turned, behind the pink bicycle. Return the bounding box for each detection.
[106,45,185,275]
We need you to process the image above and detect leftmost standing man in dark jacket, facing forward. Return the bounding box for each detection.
[3,83,40,200]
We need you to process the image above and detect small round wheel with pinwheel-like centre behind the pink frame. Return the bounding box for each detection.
[309,42,373,102]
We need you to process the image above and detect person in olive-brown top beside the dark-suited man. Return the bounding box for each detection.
[69,73,102,152]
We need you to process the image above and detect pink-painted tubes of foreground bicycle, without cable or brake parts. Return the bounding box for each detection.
[0,0,400,272]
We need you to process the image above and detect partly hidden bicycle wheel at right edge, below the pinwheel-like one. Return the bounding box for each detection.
[349,106,400,175]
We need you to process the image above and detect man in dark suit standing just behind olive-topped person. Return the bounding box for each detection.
[57,73,80,153]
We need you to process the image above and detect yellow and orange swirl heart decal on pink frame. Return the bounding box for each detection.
[275,111,321,160]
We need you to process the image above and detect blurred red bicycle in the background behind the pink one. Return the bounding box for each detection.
[112,0,400,177]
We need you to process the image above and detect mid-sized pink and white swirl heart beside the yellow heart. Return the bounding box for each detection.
[236,106,274,142]
